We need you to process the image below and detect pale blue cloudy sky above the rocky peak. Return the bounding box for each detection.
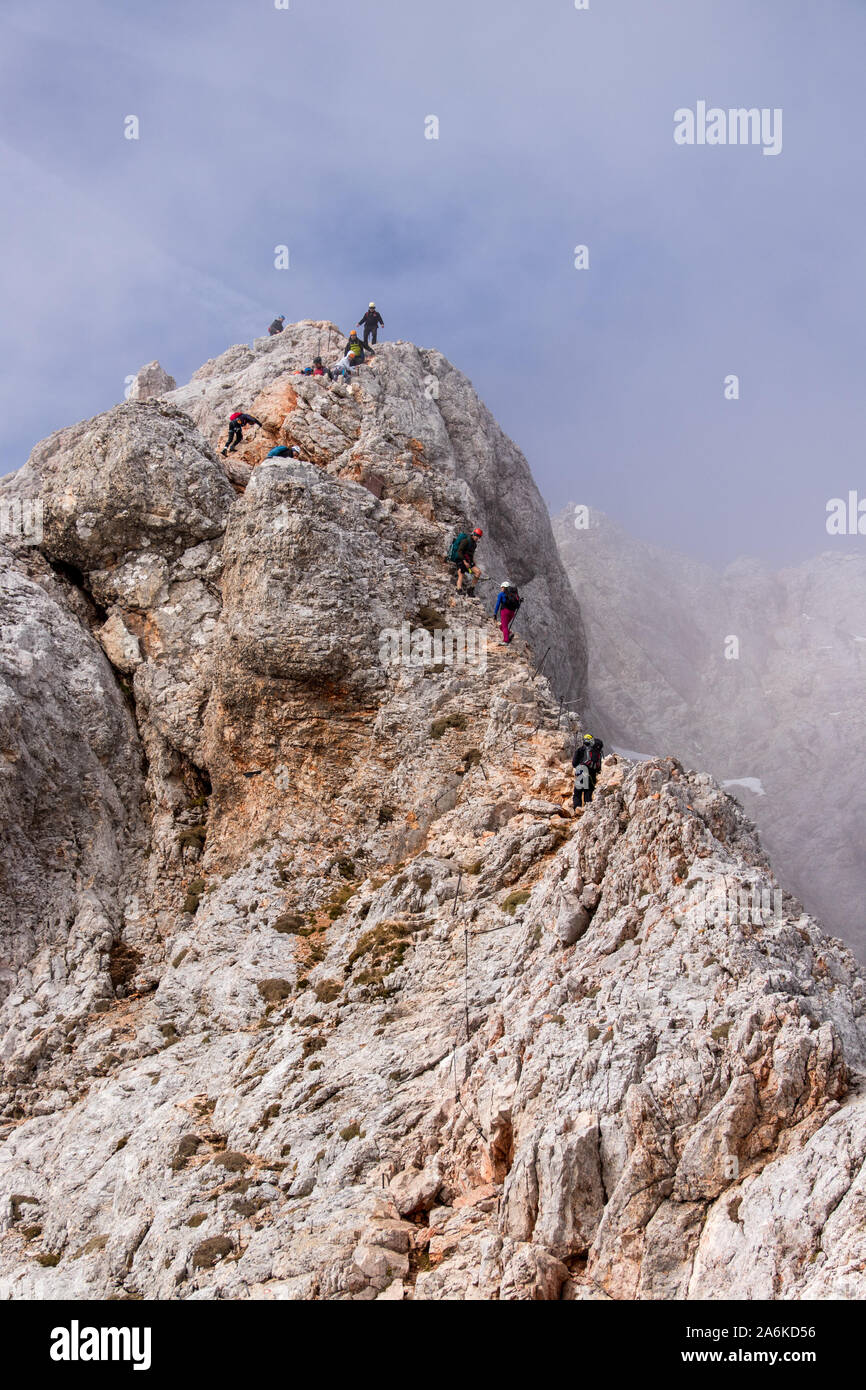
[0,0,866,564]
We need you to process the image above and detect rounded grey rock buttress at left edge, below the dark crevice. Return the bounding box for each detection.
[0,550,146,1078]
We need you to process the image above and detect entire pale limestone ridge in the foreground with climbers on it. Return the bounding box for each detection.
[0,324,866,1301]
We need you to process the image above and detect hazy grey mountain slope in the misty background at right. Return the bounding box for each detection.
[555,509,866,959]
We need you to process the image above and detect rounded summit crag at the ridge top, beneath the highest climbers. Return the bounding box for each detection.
[165,322,587,701]
